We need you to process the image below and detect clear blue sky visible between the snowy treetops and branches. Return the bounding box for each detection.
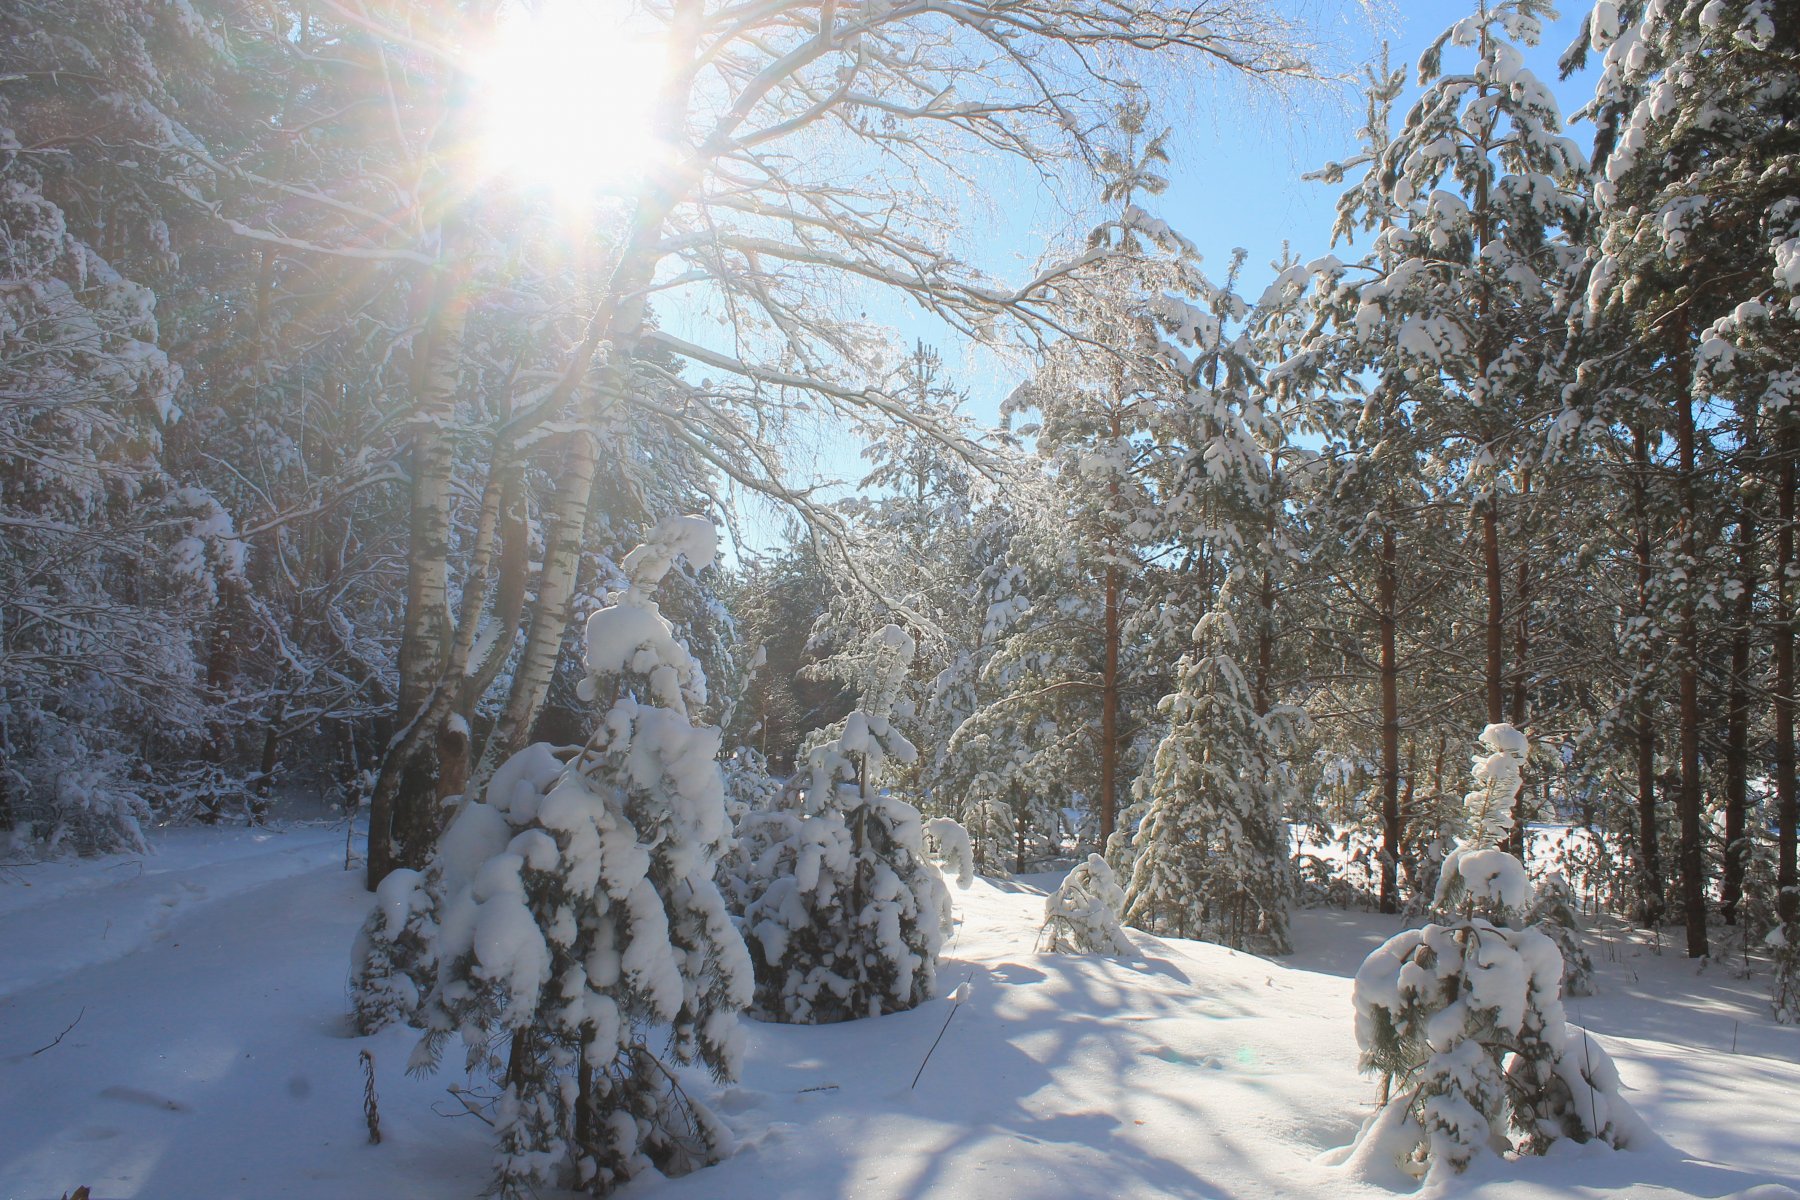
[709,0,1591,547]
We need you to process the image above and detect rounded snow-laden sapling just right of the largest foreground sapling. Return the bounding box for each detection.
[742,626,950,1024]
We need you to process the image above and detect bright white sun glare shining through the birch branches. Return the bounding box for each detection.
[473,0,662,198]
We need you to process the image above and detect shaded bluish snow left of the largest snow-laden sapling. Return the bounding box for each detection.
[0,829,488,1200]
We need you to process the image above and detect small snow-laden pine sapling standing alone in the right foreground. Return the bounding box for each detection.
[1354,725,1647,1178]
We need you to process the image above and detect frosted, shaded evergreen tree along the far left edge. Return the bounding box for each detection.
[0,11,232,855]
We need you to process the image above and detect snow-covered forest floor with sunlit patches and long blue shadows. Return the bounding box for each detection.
[0,828,1800,1200]
